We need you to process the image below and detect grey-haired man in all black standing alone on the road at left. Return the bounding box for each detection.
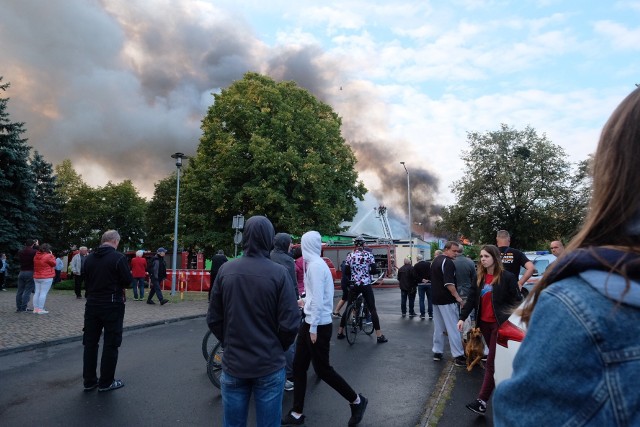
[82,230,133,391]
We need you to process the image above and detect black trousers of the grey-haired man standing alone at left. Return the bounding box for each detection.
[82,303,124,387]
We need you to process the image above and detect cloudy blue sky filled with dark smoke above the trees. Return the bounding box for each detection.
[0,0,640,237]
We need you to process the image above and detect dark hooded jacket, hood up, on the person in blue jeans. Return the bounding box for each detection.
[207,216,300,378]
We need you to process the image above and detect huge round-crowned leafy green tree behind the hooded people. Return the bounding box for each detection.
[181,73,366,252]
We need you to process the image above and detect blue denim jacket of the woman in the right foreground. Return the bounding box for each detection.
[493,270,640,427]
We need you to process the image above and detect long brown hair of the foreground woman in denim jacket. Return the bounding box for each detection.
[522,88,640,323]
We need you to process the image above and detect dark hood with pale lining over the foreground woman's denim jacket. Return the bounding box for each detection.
[549,247,640,308]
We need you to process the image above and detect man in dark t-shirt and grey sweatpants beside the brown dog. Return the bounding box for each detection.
[431,241,466,366]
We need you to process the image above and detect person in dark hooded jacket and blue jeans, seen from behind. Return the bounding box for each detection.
[207,216,300,425]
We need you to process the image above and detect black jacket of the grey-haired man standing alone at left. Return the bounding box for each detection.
[84,245,133,305]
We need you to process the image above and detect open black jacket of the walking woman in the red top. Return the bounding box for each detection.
[460,270,522,325]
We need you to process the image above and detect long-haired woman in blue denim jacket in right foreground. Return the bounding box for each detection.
[493,89,640,426]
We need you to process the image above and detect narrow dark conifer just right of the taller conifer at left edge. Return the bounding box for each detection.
[31,151,67,253]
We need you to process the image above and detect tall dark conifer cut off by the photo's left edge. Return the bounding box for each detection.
[0,77,38,263]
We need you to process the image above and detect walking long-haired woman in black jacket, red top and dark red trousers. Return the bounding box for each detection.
[458,245,522,415]
